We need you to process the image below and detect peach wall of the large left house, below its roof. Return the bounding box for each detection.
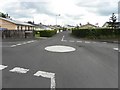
[0,19,34,30]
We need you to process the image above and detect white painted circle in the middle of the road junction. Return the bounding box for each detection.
[45,45,76,52]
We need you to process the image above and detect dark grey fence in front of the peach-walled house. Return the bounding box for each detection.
[0,30,34,39]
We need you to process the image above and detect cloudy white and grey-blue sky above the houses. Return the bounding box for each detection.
[0,0,119,26]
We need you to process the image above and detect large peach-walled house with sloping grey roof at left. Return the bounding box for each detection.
[0,17,34,31]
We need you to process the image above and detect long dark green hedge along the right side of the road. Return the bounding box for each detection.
[72,28,120,39]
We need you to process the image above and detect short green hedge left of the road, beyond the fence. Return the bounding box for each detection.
[36,30,57,37]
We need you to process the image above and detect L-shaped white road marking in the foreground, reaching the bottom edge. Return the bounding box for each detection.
[34,71,56,89]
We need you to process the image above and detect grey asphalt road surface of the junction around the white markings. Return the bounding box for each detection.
[2,31,119,88]
